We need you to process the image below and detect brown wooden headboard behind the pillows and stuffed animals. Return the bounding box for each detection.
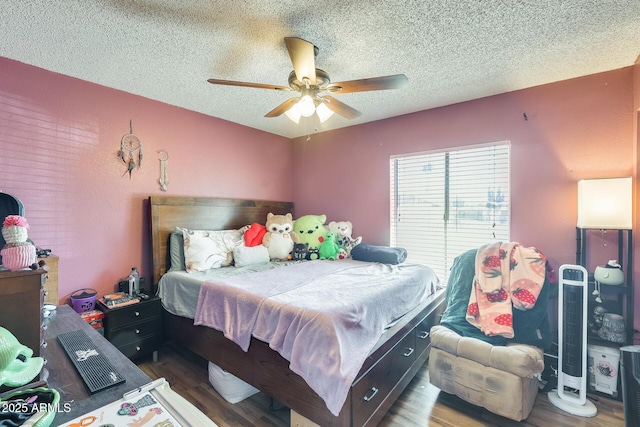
[149,196,293,286]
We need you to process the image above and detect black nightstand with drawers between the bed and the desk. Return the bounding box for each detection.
[96,296,163,361]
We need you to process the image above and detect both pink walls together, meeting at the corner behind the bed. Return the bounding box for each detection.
[0,58,640,342]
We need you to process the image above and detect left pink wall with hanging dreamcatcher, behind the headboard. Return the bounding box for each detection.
[0,58,292,303]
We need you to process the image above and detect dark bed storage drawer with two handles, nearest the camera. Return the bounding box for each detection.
[351,330,416,426]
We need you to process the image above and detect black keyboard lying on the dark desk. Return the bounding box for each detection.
[58,330,126,394]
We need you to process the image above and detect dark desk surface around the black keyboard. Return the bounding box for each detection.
[42,305,151,425]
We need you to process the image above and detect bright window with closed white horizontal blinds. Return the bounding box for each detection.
[390,142,510,284]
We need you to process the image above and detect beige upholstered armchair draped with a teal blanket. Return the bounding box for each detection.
[429,250,551,421]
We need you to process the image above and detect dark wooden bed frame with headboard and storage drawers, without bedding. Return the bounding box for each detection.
[149,196,444,426]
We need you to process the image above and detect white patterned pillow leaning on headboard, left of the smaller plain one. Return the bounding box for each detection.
[182,228,242,273]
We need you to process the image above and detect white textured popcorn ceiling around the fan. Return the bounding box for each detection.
[0,0,640,137]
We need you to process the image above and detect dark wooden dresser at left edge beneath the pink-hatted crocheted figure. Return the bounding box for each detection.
[0,269,47,356]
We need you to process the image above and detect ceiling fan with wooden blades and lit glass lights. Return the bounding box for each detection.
[207,37,409,123]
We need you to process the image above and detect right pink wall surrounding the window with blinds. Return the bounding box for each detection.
[293,67,640,342]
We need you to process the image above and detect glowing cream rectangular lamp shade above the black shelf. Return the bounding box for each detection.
[578,177,633,230]
